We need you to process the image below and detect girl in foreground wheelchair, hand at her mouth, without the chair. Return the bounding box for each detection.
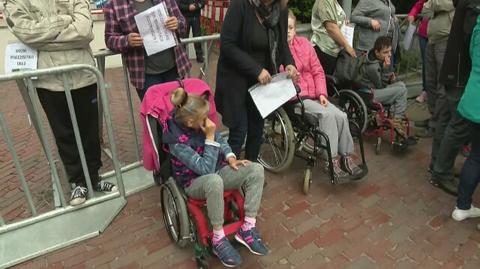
[162,88,268,267]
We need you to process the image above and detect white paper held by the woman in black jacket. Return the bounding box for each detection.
[248,72,297,118]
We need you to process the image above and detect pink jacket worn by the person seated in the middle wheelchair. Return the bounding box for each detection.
[289,36,328,99]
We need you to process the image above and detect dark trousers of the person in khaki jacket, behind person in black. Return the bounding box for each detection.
[425,40,448,125]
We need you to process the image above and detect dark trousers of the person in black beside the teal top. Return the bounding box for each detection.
[431,88,470,179]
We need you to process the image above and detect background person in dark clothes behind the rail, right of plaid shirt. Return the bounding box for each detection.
[177,0,205,63]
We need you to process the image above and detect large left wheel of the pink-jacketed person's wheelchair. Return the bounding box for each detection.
[258,108,295,173]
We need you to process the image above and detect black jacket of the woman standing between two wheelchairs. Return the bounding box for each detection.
[215,0,294,127]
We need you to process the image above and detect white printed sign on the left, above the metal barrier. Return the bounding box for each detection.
[5,42,38,73]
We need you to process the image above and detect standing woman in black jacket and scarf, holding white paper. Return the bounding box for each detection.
[215,0,298,161]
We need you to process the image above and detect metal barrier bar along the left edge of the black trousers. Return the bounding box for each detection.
[26,78,67,207]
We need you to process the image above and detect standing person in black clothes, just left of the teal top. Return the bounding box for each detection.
[430,0,480,195]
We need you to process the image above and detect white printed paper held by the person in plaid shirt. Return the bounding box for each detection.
[135,2,177,56]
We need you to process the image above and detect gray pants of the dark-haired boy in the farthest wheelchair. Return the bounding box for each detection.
[373,81,408,117]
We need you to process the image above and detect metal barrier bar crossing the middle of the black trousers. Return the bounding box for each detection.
[62,73,95,198]
